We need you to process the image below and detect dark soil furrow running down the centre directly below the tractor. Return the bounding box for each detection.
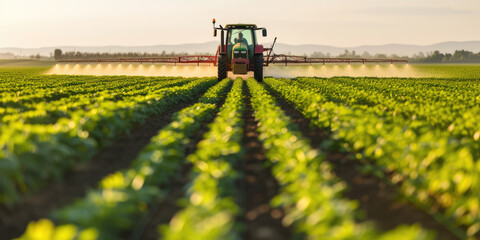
[242,84,291,240]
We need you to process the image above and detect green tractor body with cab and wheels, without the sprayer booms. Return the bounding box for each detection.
[213,19,267,82]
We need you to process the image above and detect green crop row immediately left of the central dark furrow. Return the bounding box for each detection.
[160,79,245,239]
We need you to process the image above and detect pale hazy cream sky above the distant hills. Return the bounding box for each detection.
[0,0,480,47]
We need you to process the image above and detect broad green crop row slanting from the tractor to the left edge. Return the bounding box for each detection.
[0,78,216,204]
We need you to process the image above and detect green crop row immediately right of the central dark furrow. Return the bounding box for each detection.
[247,79,432,240]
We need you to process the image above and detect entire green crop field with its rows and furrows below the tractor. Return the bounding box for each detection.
[0,66,480,240]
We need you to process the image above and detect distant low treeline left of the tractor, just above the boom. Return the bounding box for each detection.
[53,49,210,60]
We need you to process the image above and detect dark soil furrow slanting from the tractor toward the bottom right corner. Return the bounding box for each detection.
[266,86,458,240]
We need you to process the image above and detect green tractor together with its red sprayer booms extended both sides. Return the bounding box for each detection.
[58,19,408,81]
